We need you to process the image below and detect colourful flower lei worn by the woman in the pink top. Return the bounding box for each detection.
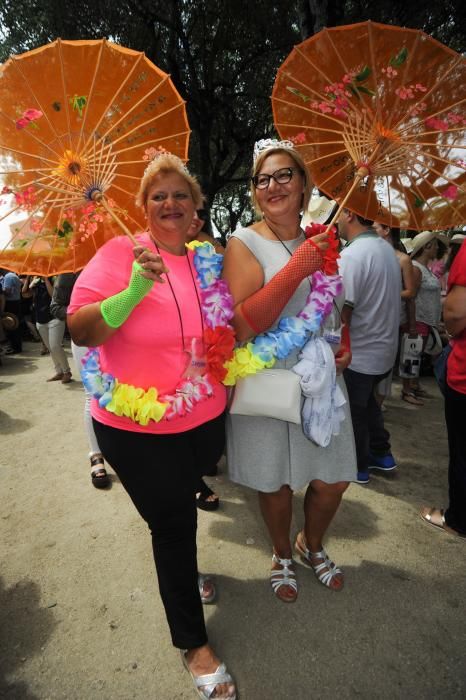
[81,241,235,425]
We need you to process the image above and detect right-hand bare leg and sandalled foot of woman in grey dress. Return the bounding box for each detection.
[297,479,349,590]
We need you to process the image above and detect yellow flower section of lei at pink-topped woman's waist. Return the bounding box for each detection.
[106,381,168,425]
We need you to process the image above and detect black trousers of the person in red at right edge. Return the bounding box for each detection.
[445,384,466,535]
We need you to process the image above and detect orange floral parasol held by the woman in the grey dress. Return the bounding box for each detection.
[272,22,466,230]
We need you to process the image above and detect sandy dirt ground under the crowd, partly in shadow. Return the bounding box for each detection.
[0,344,466,700]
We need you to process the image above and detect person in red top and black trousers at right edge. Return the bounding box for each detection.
[420,242,466,537]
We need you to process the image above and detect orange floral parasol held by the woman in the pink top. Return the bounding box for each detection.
[0,40,190,276]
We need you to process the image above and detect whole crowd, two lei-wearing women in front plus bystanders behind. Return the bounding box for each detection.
[0,139,466,698]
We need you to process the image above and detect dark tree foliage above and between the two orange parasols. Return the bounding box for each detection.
[0,0,466,238]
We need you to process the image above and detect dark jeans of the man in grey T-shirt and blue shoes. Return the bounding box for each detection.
[343,368,391,472]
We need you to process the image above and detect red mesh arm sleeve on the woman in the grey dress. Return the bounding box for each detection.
[239,240,323,334]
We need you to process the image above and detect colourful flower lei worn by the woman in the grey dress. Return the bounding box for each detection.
[223,224,343,386]
